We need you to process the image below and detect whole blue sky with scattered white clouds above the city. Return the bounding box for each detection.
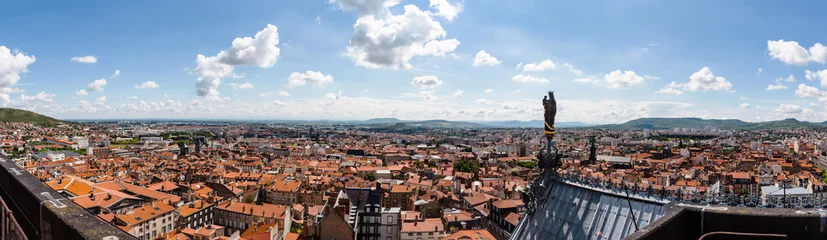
[0,0,827,123]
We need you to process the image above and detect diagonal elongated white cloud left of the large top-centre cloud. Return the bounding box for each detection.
[193,24,280,99]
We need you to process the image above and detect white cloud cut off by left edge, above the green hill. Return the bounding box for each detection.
[0,46,36,103]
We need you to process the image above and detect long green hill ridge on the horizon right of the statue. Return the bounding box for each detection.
[590,118,827,130]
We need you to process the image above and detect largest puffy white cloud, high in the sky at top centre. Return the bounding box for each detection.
[342,0,460,69]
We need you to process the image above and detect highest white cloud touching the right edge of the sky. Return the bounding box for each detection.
[767,39,827,66]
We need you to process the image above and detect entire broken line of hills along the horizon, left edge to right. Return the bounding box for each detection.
[0,108,827,130]
